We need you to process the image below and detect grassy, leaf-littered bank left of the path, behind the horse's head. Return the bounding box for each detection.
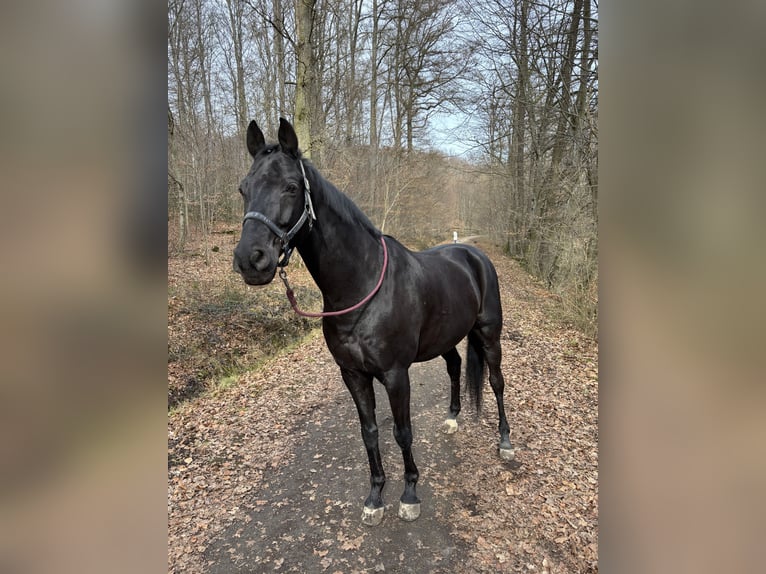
[168,228,321,408]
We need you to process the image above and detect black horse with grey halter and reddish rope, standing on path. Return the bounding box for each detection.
[234,119,514,525]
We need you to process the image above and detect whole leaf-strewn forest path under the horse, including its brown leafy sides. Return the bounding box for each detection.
[168,244,598,574]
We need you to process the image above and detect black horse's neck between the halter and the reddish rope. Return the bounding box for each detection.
[297,178,383,310]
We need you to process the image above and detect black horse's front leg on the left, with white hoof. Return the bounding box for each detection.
[341,369,386,526]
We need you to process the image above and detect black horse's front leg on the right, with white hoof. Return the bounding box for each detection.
[383,369,420,521]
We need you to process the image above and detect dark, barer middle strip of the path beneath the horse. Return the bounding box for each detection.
[206,357,474,574]
